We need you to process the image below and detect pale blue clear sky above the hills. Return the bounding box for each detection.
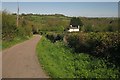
[2,2,118,17]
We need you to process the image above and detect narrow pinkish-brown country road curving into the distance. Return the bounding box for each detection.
[2,35,48,78]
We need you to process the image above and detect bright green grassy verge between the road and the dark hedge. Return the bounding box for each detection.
[36,37,120,78]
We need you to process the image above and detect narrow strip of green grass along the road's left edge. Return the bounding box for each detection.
[2,37,31,50]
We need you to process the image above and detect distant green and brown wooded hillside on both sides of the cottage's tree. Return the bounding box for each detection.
[21,14,118,32]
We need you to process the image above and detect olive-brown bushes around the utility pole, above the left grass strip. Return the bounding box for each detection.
[2,11,32,41]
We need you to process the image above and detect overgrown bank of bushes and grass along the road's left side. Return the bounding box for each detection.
[1,11,32,49]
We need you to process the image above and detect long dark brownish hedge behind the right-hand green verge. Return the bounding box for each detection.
[66,32,120,65]
